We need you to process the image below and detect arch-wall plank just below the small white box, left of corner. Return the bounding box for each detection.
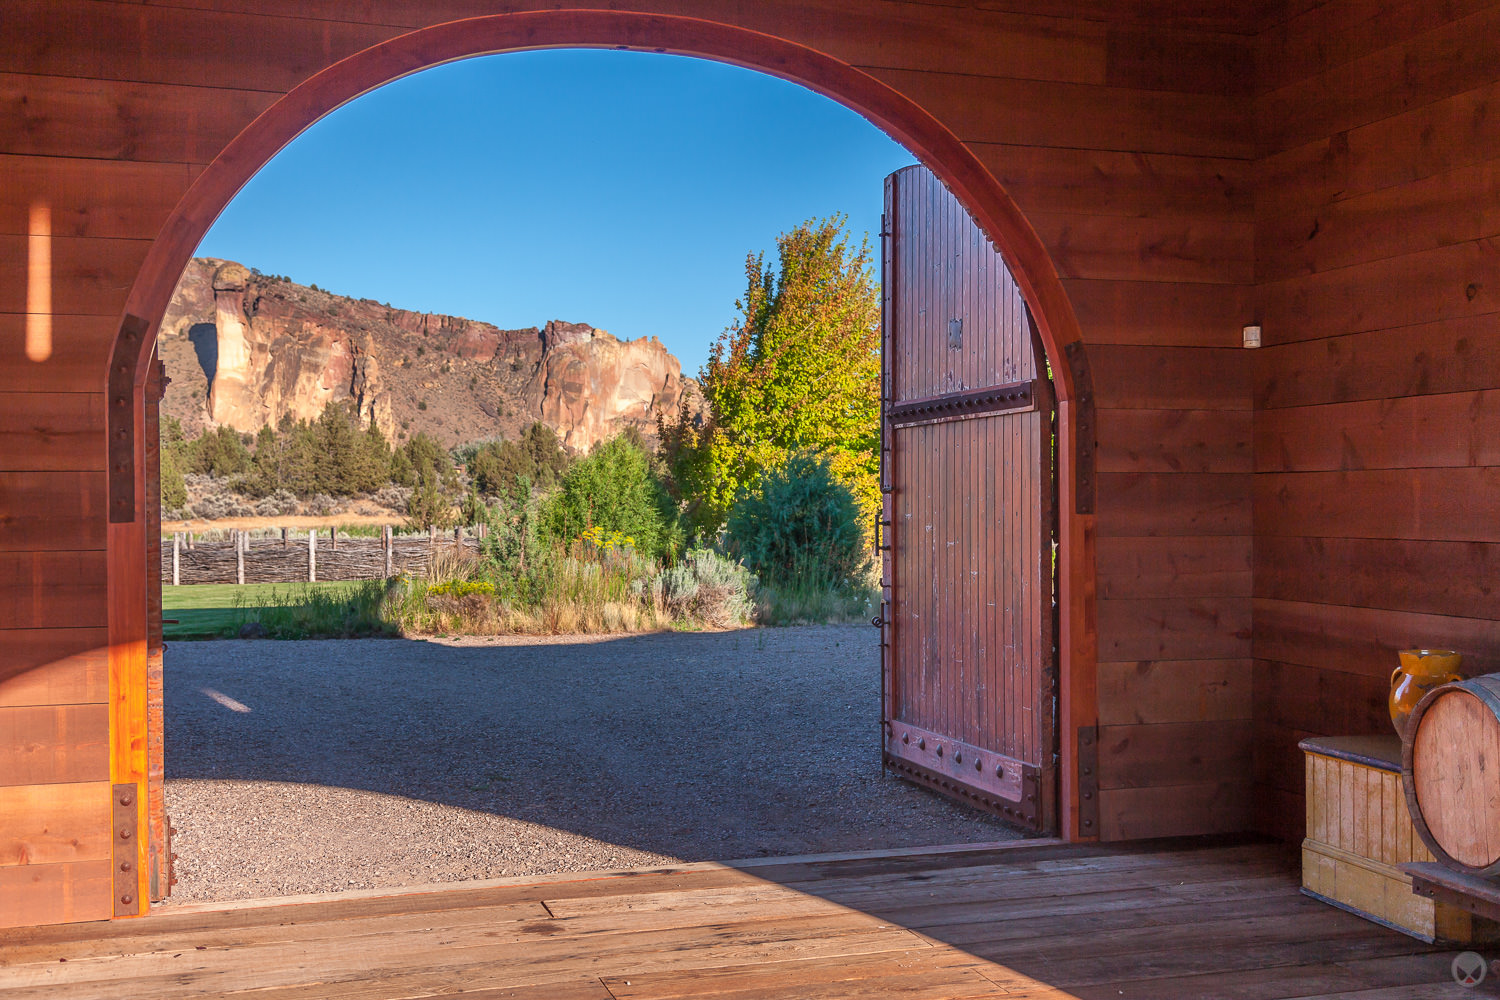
[1089,344,1254,407]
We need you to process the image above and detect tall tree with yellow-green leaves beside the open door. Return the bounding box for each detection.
[660,216,881,534]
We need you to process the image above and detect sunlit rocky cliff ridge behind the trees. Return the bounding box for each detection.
[158,258,702,451]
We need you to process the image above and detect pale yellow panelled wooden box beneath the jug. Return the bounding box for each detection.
[1299,736,1500,945]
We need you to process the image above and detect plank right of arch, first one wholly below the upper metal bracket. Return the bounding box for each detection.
[1095,535,1253,598]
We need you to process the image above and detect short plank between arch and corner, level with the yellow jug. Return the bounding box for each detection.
[1098,658,1253,726]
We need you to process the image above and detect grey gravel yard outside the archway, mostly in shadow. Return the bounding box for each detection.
[167,627,1014,903]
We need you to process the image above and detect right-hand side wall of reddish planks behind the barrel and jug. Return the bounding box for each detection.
[1254,0,1500,838]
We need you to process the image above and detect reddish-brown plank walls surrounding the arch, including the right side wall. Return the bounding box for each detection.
[0,0,1476,924]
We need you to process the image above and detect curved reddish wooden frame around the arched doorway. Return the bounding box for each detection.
[108,9,1098,840]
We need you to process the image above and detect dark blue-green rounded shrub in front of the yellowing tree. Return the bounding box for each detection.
[728,451,869,588]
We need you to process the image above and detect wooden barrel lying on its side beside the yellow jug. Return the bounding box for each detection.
[1401,673,1500,876]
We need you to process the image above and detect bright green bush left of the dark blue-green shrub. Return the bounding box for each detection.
[542,435,678,556]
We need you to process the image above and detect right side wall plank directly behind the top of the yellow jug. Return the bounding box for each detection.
[1254,597,1500,684]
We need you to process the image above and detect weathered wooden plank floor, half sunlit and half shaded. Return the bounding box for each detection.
[0,843,1473,1000]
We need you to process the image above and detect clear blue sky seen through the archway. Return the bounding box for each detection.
[198,49,915,373]
